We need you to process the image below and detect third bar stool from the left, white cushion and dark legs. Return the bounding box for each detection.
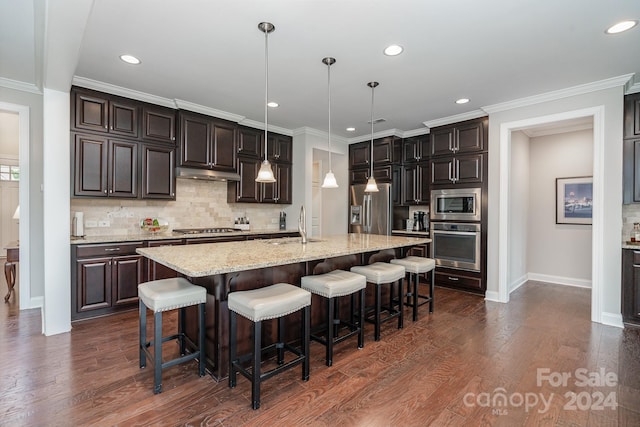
[301,270,367,366]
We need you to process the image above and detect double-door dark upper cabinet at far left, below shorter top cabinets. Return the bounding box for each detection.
[73,134,138,198]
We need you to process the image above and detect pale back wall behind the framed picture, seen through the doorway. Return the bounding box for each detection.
[528,129,593,287]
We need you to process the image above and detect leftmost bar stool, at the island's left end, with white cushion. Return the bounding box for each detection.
[138,277,207,394]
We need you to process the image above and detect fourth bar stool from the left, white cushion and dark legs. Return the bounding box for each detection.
[351,262,405,341]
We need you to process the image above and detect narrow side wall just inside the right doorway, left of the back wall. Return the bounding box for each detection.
[508,131,536,291]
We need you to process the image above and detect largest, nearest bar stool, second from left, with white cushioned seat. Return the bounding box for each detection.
[228,283,311,409]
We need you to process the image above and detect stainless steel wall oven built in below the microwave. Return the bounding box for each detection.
[431,222,480,271]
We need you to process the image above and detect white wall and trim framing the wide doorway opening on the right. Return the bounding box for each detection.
[487,84,624,326]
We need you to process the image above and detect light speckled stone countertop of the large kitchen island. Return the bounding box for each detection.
[136,234,431,277]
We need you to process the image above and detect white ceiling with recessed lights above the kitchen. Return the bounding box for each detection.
[0,0,640,141]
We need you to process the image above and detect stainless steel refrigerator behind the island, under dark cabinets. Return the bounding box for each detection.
[349,184,393,235]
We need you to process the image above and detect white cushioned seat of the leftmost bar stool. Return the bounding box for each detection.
[138,277,207,313]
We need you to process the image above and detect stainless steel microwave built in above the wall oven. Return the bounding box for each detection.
[429,188,482,221]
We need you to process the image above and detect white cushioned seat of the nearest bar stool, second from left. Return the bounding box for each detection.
[228,283,311,322]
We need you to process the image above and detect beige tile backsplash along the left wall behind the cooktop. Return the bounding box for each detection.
[71,179,283,236]
